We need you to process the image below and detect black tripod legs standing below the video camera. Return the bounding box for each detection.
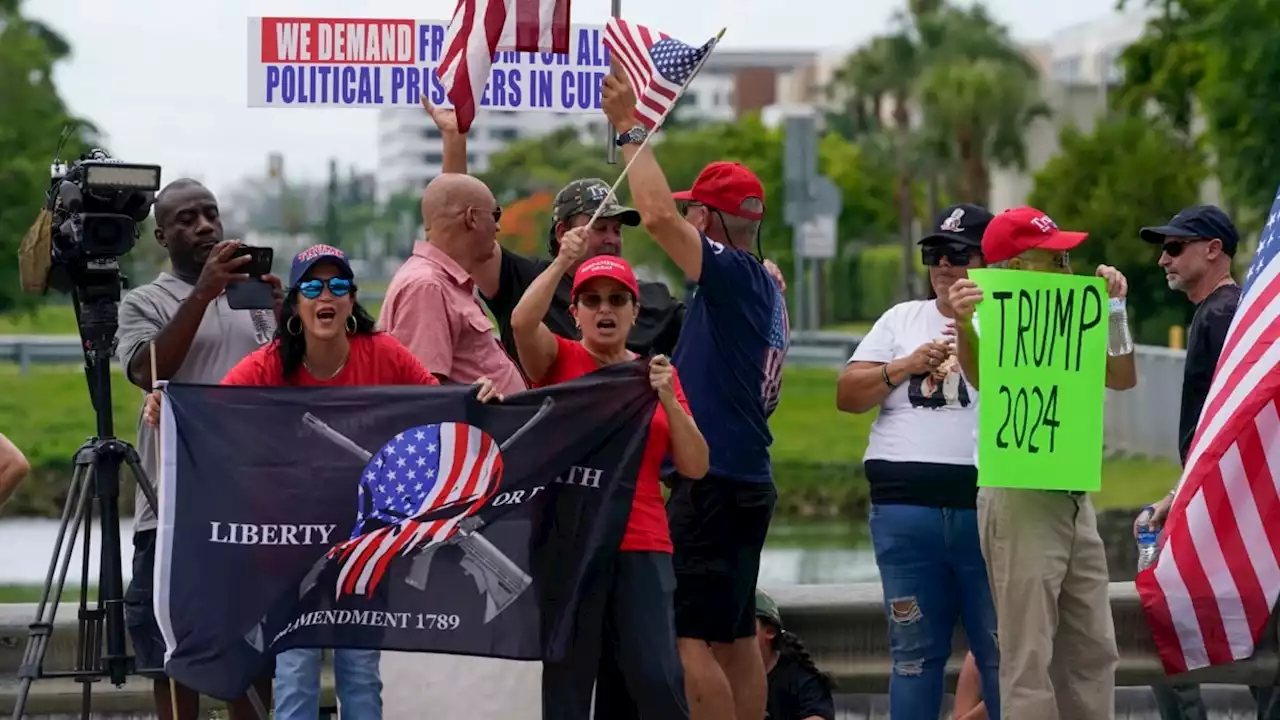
[13,270,160,720]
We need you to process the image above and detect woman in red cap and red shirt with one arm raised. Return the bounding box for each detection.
[511,228,709,720]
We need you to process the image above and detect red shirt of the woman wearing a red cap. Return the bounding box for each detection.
[538,336,689,552]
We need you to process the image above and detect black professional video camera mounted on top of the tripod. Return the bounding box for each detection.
[45,149,160,292]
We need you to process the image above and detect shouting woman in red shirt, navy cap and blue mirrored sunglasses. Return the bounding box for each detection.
[146,245,502,720]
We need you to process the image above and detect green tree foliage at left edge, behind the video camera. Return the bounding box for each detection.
[0,0,95,313]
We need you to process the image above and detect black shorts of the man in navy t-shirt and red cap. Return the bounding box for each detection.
[667,475,778,643]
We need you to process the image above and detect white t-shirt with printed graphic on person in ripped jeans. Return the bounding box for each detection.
[849,300,978,465]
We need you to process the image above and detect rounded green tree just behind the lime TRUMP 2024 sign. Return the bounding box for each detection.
[1028,115,1208,345]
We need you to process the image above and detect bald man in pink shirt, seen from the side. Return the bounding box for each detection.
[378,173,527,395]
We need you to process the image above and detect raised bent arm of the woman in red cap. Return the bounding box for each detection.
[511,228,586,383]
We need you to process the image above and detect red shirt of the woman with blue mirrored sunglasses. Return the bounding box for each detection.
[221,332,440,387]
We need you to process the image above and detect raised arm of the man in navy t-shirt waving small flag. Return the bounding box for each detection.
[603,72,703,282]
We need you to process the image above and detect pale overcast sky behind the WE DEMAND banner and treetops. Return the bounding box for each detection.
[23,0,1115,192]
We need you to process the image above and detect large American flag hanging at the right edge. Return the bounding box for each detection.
[1137,184,1280,675]
